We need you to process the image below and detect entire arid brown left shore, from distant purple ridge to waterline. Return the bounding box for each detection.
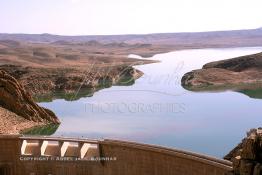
[0,40,156,99]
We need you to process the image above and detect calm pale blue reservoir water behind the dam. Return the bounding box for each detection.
[40,47,262,157]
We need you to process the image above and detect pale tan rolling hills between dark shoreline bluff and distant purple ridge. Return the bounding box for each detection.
[0,40,157,68]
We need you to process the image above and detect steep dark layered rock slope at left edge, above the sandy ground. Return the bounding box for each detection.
[0,70,60,124]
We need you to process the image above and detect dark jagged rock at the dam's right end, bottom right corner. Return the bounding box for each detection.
[224,128,262,175]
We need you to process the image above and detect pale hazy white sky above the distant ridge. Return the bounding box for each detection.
[0,0,262,35]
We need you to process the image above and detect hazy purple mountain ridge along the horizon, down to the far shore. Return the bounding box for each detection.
[0,28,262,49]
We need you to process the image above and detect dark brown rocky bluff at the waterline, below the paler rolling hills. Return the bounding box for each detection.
[0,65,143,100]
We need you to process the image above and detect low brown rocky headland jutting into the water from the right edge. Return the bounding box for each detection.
[181,53,262,91]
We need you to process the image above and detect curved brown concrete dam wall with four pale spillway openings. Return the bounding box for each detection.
[0,135,232,175]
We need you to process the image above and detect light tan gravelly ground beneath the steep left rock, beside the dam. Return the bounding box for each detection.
[0,107,44,134]
